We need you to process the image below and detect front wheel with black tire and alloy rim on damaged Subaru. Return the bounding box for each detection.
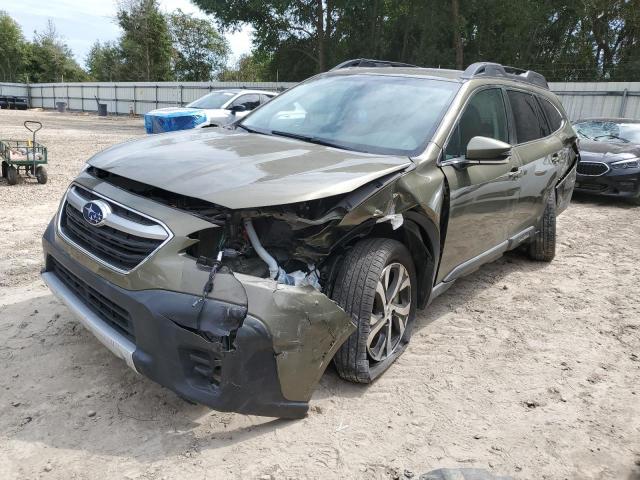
[332,238,417,383]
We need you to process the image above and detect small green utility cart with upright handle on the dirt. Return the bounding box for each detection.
[0,120,47,185]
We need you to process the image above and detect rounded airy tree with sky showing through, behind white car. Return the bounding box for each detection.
[168,9,229,81]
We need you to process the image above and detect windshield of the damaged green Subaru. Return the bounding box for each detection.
[240,75,459,155]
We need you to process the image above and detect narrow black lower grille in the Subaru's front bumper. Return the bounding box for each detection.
[48,257,135,343]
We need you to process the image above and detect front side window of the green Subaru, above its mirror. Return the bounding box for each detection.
[444,88,509,160]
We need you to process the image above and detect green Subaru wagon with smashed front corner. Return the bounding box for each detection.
[42,59,578,418]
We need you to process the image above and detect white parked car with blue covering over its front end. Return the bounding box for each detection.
[144,89,277,133]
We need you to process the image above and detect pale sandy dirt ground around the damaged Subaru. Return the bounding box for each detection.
[0,111,640,480]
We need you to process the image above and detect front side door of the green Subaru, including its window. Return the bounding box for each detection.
[438,87,520,281]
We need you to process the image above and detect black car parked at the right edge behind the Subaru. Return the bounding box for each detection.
[574,118,640,205]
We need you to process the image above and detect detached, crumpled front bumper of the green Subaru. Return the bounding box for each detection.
[43,222,355,418]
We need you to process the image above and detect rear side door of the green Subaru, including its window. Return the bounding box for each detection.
[507,88,564,236]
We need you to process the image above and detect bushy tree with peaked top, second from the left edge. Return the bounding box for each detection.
[24,20,87,83]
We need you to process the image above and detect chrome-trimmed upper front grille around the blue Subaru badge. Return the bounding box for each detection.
[59,186,169,272]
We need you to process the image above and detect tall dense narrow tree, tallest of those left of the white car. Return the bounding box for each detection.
[117,0,172,82]
